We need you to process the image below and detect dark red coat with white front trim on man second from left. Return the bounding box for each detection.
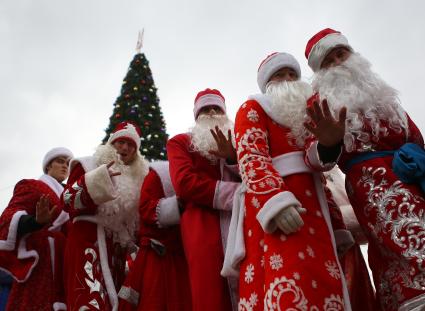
[63,160,126,310]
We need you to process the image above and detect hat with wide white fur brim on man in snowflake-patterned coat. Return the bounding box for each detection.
[257,52,301,93]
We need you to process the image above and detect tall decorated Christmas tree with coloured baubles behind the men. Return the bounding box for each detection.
[103,33,168,161]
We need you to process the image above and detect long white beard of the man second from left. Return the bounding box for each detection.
[94,144,149,247]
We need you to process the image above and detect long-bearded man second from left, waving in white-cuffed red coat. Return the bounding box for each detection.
[63,122,148,310]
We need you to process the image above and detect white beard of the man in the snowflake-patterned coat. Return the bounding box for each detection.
[266,80,313,147]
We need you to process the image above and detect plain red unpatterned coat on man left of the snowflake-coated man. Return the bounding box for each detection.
[167,134,237,311]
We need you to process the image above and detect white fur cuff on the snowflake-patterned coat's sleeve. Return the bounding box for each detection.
[257,191,301,233]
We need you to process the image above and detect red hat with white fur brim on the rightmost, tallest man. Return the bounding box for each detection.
[305,28,353,72]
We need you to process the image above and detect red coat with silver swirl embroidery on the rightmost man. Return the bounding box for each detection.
[332,113,425,310]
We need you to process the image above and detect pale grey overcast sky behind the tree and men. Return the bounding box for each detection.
[0,0,425,210]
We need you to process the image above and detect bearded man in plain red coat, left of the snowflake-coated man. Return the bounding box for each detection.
[167,89,240,311]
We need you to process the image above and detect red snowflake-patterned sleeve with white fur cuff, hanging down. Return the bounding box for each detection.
[235,100,301,233]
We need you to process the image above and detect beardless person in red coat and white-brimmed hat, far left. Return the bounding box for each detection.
[0,147,73,311]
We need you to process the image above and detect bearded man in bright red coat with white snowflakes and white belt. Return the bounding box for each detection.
[235,53,351,310]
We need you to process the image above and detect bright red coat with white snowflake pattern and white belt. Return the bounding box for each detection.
[235,97,350,310]
